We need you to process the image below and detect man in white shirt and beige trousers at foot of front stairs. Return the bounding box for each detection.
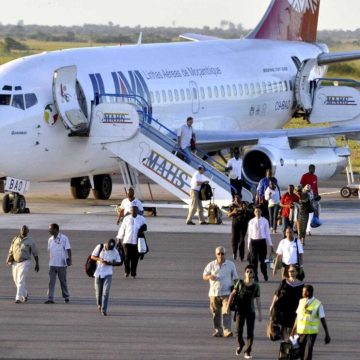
[186,165,208,225]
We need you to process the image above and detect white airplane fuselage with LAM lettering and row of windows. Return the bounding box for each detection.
[0,40,324,181]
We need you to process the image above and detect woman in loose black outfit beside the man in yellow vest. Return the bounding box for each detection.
[270,265,304,341]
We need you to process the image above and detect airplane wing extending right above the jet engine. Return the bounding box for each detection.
[196,125,360,151]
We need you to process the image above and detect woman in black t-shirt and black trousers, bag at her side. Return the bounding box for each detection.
[229,265,262,359]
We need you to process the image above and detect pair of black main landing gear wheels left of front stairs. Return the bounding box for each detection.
[70,174,112,200]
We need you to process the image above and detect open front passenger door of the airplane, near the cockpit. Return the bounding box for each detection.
[52,65,89,133]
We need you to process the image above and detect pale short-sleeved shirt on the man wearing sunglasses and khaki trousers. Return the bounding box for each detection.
[203,260,239,297]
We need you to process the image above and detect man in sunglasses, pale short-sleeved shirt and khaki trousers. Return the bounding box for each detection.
[203,246,238,337]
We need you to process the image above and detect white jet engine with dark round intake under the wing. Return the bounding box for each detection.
[243,145,349,188]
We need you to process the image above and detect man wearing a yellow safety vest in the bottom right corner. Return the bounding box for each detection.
[291,285,331,360]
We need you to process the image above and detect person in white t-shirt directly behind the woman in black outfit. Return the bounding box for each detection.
[273,226,304,280]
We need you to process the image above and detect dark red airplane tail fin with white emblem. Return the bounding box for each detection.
[247,0,320,42]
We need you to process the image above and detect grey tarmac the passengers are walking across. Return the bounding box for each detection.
[0,181,360,360]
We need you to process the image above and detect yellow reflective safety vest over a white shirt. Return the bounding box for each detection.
[297,298,321,334]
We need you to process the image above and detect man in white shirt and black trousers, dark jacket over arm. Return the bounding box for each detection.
[116,204,147,279]
